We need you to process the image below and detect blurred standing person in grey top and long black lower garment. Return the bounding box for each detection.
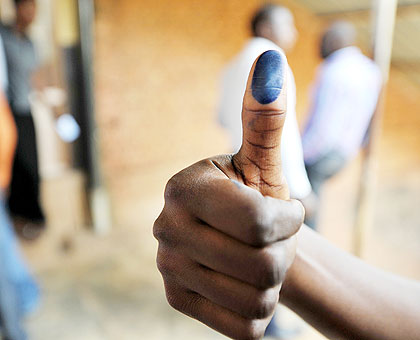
[0,0,45,239]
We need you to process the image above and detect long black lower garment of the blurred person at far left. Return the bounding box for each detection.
[8,113,45,223]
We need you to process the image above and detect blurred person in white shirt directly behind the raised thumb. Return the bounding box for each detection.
[218,4,314,337]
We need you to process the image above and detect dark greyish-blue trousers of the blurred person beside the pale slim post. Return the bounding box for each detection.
[305,151,347,230]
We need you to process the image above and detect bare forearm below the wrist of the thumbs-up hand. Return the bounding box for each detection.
[281,227,420,340]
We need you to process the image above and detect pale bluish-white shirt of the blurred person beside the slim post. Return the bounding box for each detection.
[302,47,382,164]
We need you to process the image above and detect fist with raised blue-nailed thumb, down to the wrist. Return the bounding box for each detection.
[154,51,304,339]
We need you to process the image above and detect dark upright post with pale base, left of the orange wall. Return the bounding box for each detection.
[55,0,111,234]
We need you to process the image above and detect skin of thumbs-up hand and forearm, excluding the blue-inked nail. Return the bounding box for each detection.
[154,53,420,340]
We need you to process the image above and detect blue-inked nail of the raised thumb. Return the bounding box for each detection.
[251,50,284,104]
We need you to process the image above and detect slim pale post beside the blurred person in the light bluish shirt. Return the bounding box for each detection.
[353,0,398,256]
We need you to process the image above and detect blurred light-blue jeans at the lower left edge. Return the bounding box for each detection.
[0,192,39,340]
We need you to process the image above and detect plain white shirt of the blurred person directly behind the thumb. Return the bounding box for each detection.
[218,38,312,199]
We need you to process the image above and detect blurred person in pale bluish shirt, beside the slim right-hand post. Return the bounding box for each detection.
[302,21,382,227]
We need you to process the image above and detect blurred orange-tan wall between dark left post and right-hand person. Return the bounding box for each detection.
[96,0,319,174]
